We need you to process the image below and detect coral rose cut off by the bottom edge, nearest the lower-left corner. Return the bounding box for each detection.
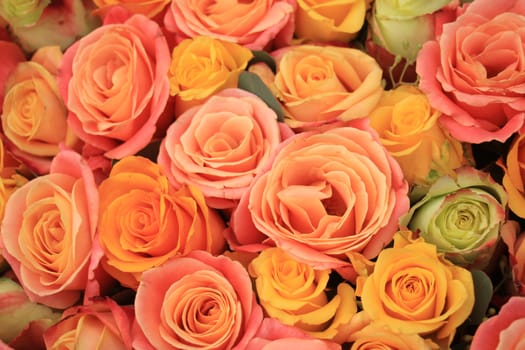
[44,298,134,350]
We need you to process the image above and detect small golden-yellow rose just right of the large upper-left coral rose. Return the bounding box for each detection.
[168,36,253,115]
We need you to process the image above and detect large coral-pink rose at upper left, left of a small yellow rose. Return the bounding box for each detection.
[59,10,169,159]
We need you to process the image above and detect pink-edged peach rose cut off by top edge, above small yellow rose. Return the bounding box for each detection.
[164,0,297,50]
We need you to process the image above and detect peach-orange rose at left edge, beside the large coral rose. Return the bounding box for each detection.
[1,46,79,174]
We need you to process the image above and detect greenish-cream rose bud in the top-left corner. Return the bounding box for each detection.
[0,0,100,53]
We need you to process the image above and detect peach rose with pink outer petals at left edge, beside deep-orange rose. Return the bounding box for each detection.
[0,151,98,309]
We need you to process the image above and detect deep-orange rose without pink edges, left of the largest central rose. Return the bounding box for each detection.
[98,156,225,289]
